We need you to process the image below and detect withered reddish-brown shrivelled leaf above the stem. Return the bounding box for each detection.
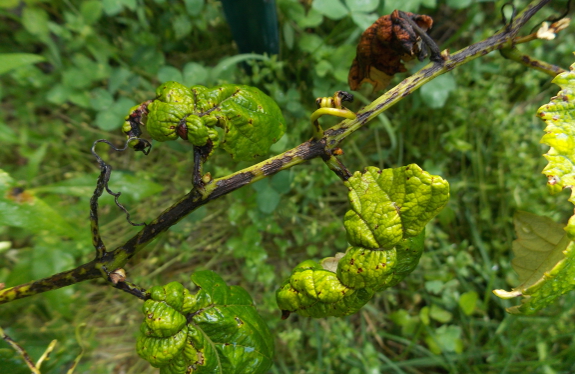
[348,10,433,92]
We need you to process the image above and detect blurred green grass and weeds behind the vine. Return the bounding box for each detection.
[0,0,575,374]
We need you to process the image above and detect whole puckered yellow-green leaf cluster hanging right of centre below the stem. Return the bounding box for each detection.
[276,164,449,318]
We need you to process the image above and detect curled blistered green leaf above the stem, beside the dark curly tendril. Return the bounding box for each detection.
[122,82,285,160]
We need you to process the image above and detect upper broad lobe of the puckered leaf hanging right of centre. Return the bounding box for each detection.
[344,164,449,249]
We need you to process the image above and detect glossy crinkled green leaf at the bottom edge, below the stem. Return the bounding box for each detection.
[136,271,274,374]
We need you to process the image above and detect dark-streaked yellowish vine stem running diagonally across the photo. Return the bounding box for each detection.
[0,0,551,304]
